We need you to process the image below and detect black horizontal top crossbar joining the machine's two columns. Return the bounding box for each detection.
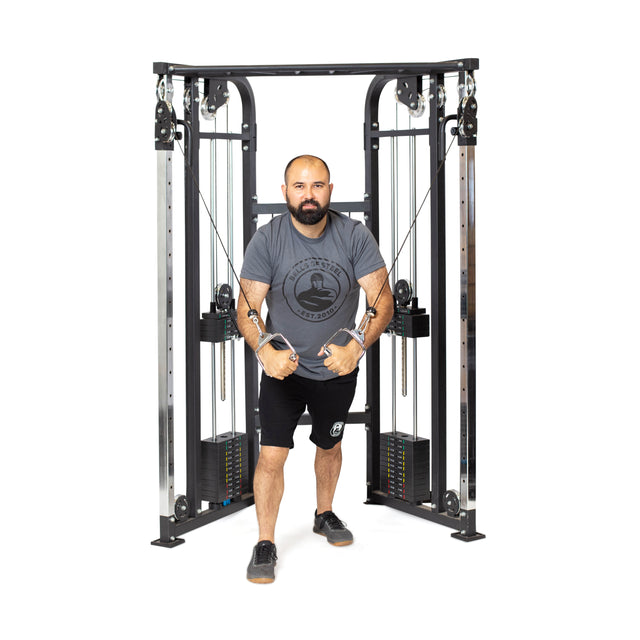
[153,58,479,78]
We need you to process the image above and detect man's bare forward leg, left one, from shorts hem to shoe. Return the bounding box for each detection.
[253,446,289,542]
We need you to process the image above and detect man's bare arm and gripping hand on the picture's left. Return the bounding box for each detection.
[238,278,298,380]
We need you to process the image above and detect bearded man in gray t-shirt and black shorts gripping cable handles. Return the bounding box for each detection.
[238,155,393,583]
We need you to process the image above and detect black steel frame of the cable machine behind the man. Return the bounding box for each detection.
[153,58,484,547]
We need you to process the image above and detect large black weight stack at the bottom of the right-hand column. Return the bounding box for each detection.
[380,431,430,503]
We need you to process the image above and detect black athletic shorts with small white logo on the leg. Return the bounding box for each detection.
[259,369,358,449]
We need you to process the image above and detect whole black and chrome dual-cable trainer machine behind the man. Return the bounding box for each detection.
[152,58,484,547]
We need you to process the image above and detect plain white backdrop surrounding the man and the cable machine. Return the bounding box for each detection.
[0,0,640,639]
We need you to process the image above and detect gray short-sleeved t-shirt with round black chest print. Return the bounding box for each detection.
[240,210,385,380]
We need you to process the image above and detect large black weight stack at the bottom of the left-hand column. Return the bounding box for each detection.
[200,431,249,504]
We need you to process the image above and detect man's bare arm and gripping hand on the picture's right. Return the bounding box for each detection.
[318,267,393,376]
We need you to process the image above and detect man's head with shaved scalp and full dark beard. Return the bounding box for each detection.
[282,159,333,225]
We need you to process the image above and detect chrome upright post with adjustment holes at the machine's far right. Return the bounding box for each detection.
[460,145,476,509]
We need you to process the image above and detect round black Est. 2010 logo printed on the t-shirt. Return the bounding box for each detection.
[282,258,351,322]
